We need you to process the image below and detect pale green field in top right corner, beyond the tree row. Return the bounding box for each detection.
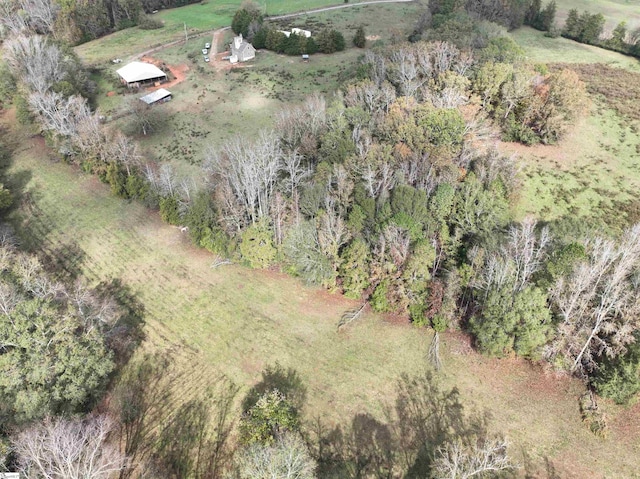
[556,0,640,30]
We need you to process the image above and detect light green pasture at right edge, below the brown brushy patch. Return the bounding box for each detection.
[518,108,640,225]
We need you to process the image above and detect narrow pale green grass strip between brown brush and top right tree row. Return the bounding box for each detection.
[509,27,640,72]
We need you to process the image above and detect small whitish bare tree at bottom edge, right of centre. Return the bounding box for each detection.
[432,439,515,479]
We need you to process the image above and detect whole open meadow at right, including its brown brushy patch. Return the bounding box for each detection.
[501,27,640,232]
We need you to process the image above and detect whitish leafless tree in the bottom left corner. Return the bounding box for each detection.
[12,416,125,479]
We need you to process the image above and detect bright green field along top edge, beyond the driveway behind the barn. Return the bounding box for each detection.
[76,0,376,65]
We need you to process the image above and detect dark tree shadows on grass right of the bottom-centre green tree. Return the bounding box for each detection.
[307,372,500,479]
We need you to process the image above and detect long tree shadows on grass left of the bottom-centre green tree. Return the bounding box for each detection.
[109,353,238,479]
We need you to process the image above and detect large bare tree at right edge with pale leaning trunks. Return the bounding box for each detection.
[547,224,640,373]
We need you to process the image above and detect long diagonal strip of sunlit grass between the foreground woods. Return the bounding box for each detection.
[3,114,640,478]
